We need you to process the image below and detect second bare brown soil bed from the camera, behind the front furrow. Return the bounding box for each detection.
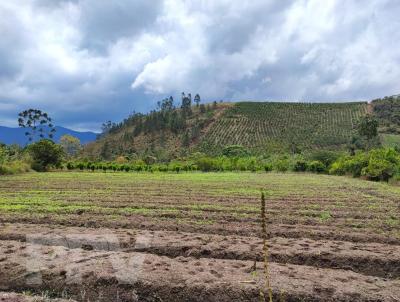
[0,224,400,279]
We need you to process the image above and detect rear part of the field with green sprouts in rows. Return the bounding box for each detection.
[0,172,400,236]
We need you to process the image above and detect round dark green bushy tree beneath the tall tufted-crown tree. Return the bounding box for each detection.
[28,139,64,172]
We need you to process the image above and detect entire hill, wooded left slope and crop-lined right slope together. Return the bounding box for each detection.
[85,102,393,159]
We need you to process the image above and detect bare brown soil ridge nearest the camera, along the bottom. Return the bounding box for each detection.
[0,241,400,302]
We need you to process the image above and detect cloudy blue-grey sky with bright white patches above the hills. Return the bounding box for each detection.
[0,0,400,130]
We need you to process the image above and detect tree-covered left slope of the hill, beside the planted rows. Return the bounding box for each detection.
[84,95,231,159]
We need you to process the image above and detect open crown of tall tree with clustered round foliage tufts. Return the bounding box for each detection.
[18,109,56,142]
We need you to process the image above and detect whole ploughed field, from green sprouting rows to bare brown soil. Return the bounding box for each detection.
[0,172,400,301]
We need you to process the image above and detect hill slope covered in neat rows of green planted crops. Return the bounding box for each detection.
[201,102,367,152]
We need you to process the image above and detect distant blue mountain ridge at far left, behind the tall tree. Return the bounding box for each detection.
[0,126,97,146]
